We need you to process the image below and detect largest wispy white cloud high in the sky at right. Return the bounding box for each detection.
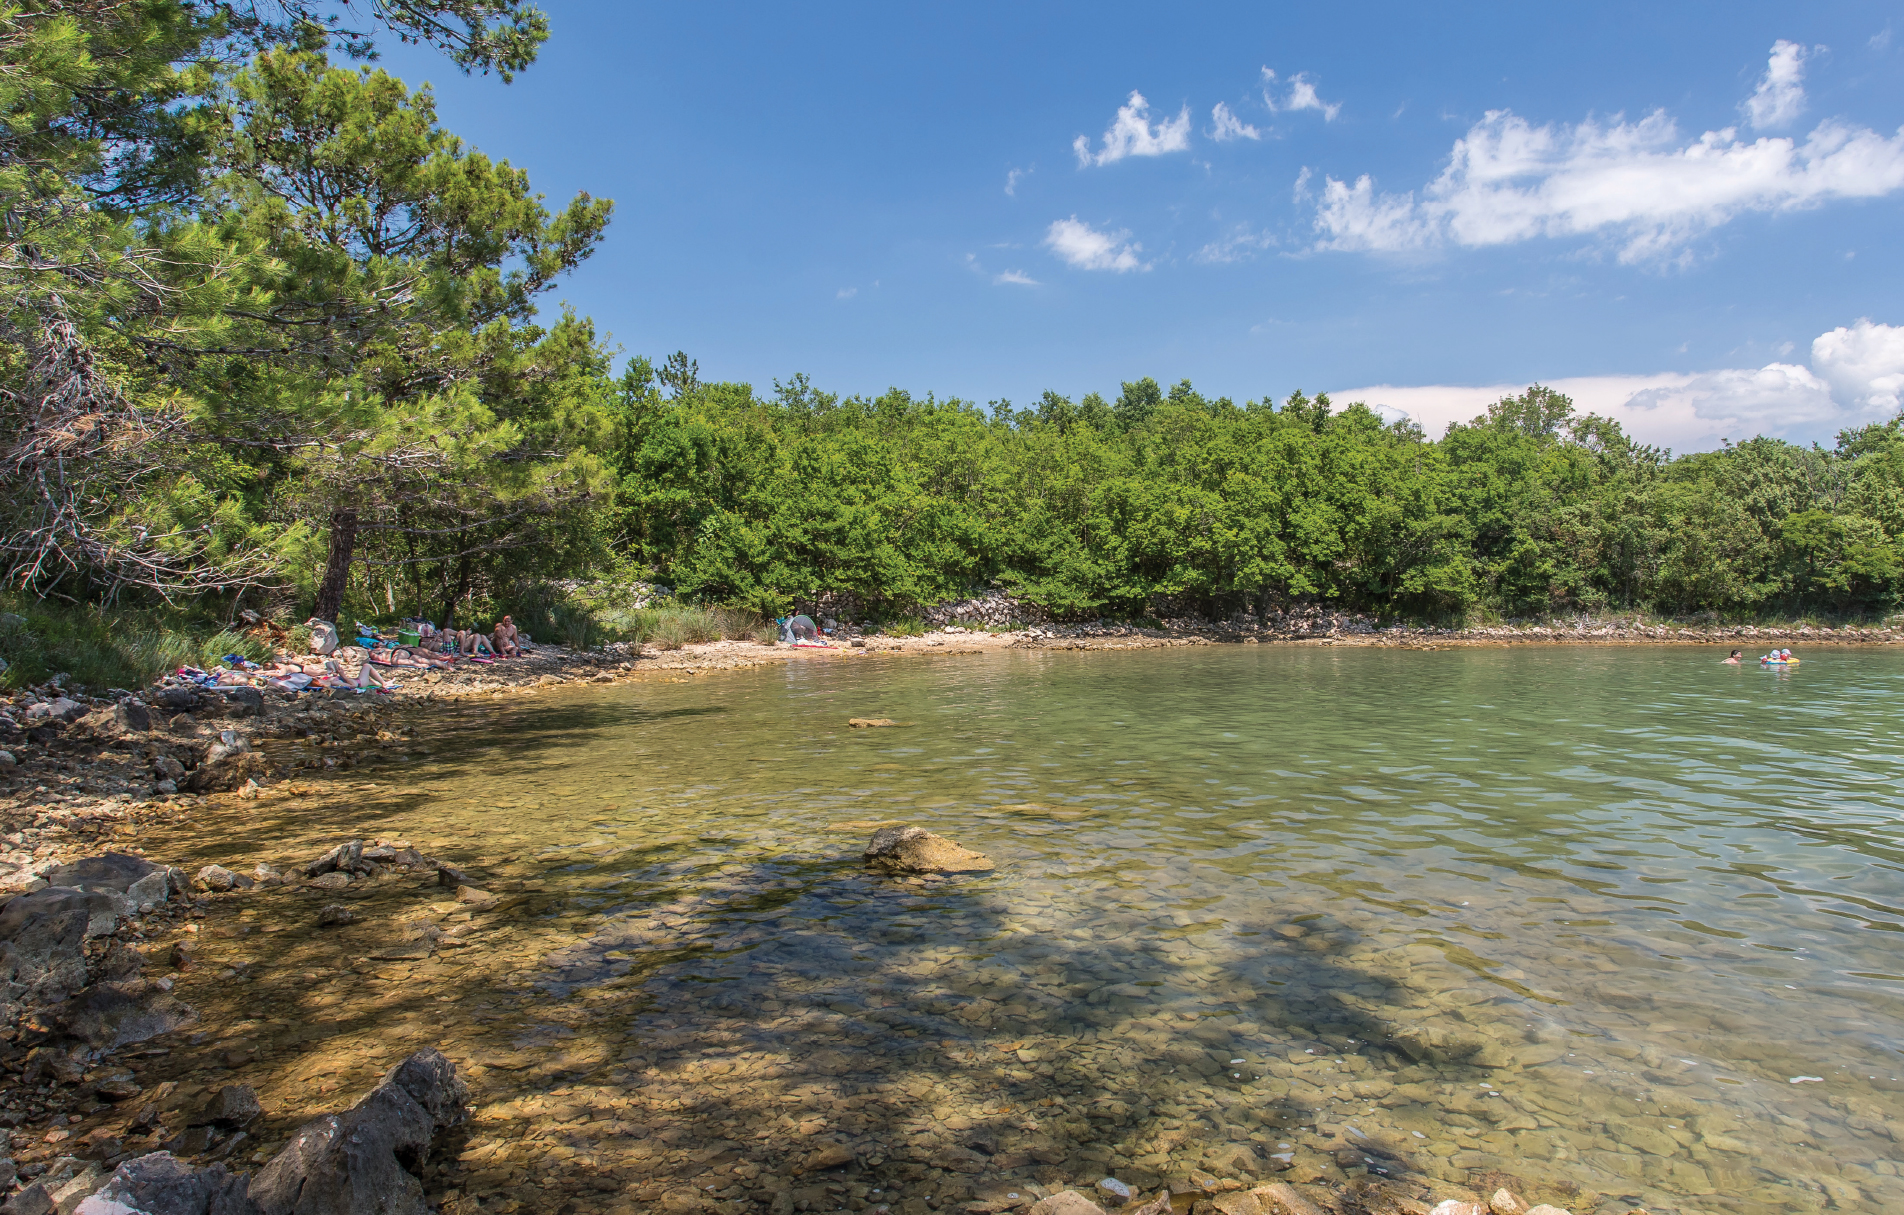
[1316,92,1904,263]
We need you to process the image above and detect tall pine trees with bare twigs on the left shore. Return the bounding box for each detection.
[0,0,611,615]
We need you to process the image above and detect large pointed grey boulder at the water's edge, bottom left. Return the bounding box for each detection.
[251,1049,468,1215]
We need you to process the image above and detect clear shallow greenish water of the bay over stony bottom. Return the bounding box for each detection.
[147,646,1904,1213]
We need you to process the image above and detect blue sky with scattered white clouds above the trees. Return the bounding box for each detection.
[383,0,1904,449]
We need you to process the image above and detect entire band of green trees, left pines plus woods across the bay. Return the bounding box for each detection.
[0,0,1904,619]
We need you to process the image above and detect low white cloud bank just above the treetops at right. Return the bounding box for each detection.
[1331,320,1904,451]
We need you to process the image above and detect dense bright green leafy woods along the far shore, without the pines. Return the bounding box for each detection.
[607,371,1904,619]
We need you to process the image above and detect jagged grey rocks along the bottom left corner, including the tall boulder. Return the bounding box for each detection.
[72,1049,468,1215]
